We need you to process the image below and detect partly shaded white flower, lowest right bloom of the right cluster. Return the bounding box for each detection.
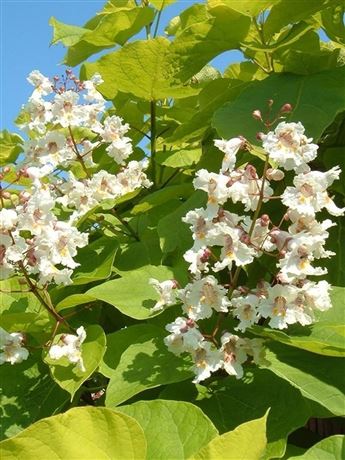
[220,332,247,379]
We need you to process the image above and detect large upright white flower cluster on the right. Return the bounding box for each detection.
[151,122,345,382]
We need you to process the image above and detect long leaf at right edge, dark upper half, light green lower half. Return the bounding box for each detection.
[266,343,345,416]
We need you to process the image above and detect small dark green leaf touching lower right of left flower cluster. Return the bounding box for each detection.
[72,236,118,285]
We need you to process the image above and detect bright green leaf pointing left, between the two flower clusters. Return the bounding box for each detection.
[86,265,180,319]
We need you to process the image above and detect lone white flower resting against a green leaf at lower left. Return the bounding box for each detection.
[49,326,86,372]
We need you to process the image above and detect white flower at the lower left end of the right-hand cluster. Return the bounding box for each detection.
[164,317,204,355]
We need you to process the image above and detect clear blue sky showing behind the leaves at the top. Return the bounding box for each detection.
[0,0,241,131]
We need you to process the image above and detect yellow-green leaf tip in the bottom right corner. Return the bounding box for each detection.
[289,434,345,460]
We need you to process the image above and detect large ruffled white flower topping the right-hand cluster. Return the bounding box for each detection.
[263,121,318,173]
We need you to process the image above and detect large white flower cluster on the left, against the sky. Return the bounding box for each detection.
[0,71,151,286]
